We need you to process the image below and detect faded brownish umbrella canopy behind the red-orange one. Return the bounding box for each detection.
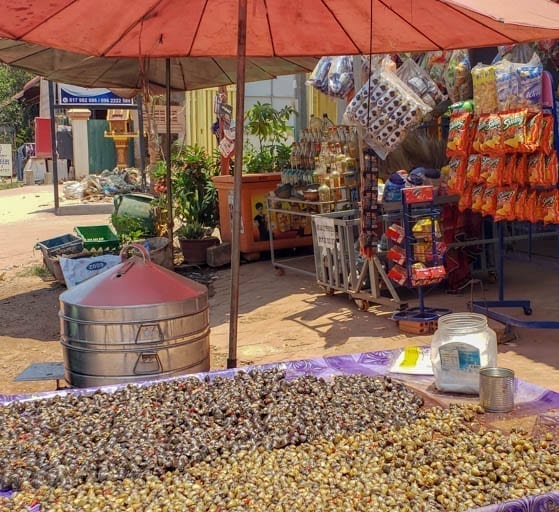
[0,39,318,91]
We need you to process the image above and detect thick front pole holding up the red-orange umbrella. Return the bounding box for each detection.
[227,0,247,368]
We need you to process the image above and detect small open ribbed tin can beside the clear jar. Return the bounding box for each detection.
[479,367,514,412]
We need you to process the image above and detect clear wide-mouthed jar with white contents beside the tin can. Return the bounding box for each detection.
[431,313,497,394]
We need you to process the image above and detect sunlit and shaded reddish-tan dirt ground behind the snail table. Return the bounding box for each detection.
[0,185,559,394]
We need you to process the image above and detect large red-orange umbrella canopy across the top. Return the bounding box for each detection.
[0,0,559,57]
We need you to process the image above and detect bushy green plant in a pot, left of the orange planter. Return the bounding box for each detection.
[152,145,220,265]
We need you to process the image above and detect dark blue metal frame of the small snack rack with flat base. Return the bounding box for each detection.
[392,193,451,322]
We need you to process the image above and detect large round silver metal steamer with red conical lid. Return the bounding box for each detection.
[59,244,210,387]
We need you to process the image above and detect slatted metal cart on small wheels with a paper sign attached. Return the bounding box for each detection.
[312,210,407,311]
